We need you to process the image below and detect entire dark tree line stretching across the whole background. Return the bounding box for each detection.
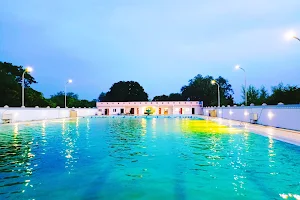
[0,62,300,107]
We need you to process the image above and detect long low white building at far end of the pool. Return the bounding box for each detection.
[97,101,203,115]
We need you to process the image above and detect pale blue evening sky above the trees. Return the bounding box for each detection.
[0,0,300,101]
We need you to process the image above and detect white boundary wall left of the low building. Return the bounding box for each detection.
[0,108,97,124]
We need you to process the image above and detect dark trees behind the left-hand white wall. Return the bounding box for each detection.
[0,62,96,107]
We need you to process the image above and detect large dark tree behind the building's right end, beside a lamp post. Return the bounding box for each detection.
[181,74,233,106]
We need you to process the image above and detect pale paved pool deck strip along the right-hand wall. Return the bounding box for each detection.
[201,116,300,146]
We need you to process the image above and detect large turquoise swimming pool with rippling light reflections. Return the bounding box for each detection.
[0,118,300,199]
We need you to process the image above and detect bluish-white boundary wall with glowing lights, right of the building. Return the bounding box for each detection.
[203,105,300,130]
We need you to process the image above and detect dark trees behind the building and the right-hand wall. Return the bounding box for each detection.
[98,74,300,106]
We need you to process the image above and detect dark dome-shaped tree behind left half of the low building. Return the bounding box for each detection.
[104,81,148,102]
